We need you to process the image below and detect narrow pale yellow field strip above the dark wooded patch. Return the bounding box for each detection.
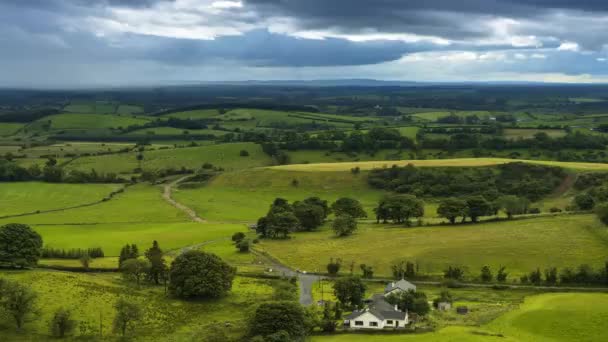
[268,158,608,172]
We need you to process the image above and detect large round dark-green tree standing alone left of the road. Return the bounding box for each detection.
[169,251,236,298]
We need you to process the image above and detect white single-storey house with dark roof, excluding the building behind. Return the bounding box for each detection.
[344,295,409,329]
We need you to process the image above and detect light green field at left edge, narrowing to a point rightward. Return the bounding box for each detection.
[0,182,121,216]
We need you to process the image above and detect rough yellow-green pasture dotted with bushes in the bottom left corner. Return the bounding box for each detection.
[0,270,273,341]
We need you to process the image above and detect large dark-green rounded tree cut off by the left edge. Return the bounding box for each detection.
[0,223,42,267]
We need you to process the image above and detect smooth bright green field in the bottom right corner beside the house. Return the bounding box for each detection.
[312,290,608,342]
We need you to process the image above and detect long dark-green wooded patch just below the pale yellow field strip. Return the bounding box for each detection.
[368,162,566,201]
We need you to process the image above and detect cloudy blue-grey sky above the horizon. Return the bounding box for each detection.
[0,0,608,88]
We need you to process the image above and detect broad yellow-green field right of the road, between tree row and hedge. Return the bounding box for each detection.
[260,215,608,278]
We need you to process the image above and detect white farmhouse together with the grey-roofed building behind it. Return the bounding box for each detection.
[344,279,416,329]
